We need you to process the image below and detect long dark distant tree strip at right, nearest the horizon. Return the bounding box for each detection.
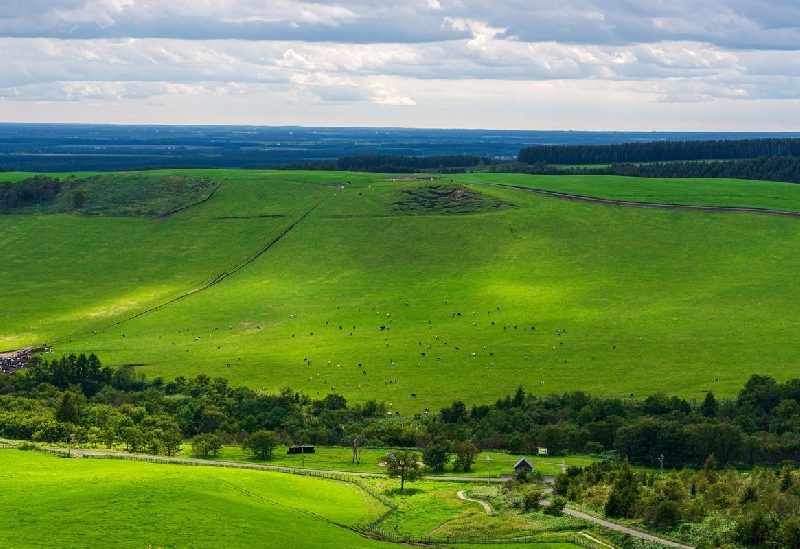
[517,138,800,165]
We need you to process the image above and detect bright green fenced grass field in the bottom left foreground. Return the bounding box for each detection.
[0,450,387,549]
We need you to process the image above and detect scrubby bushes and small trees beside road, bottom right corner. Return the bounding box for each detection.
[554,455,800,548]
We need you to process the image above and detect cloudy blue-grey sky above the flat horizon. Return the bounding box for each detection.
[0,0,800,131]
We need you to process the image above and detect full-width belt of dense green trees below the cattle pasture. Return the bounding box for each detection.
[0,355,800,471]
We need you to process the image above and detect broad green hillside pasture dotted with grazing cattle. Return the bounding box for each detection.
[0,171,800,414]
